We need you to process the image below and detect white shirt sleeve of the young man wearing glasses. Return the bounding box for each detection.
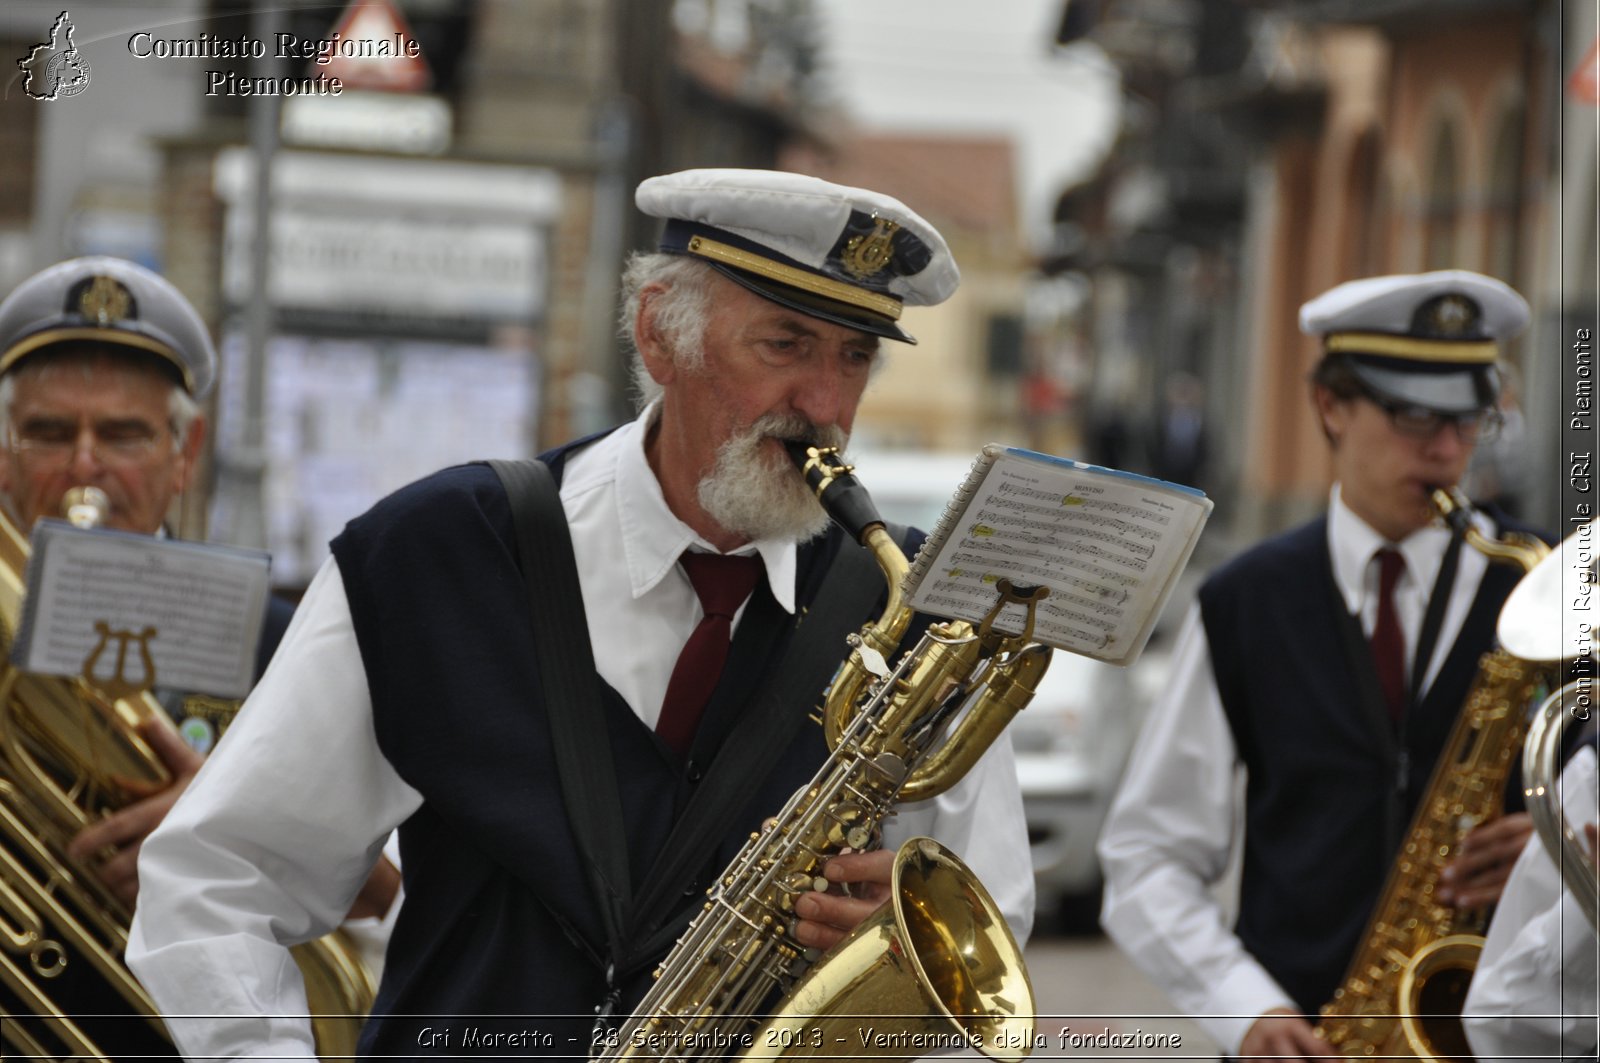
[1099,607,1296,1055]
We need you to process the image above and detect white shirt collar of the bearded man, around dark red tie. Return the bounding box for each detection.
[616,402,798,613]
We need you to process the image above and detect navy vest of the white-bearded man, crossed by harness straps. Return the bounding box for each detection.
[333,451,915,1057]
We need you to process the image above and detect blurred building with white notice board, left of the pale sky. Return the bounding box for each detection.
[0,0,857,583]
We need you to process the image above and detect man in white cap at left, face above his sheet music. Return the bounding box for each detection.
[0,256,398,954]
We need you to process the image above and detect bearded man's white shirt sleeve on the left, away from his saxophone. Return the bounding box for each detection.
[128,560,421,1060]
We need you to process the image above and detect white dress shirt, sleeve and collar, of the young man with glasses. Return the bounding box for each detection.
[1099,485,1491,1055]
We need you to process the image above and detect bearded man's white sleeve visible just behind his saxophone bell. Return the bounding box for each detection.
[883,733,1034,945]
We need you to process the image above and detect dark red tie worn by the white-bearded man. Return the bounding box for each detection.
[656,554,762,756]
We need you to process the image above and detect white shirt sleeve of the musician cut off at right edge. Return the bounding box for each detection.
[1462,748,1600,1060]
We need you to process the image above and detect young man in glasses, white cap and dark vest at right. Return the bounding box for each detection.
[1099,271,1531,1058]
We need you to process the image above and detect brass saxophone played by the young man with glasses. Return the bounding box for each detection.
[1317,488,1554,1060]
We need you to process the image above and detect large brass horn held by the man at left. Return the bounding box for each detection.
[0,488,374,1060]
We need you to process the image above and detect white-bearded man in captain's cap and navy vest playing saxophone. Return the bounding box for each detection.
[130,170,1032,1058]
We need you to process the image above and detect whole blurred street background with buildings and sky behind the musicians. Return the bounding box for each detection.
[0,0,1600,1058]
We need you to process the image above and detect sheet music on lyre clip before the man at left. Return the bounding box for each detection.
[11,520,269,698]
